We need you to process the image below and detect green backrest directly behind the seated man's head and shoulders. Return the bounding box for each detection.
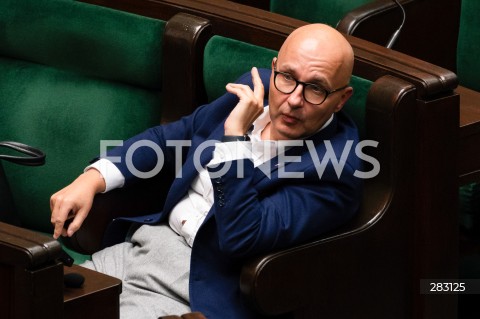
[203,36,372,137]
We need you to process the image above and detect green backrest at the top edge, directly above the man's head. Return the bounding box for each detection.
[270,0,372,27]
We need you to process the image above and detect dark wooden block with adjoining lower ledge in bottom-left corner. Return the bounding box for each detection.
[0,222,121,319]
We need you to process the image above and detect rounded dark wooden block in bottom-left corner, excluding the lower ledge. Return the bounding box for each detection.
[0,222,63,318]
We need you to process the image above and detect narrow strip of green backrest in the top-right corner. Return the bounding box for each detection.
[457,0,480,91]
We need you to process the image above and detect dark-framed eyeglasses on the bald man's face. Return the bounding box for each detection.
[273,61,348,105]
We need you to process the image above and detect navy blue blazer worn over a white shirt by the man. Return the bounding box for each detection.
[104,69,361,319]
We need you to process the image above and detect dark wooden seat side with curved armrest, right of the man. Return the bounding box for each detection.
[240,76,415,318]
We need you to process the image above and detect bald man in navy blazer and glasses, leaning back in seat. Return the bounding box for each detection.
[51,24,361,319]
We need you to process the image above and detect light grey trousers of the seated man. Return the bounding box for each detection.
[81,225,191,319]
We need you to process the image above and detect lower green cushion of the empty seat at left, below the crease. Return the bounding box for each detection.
[0,58,161,231]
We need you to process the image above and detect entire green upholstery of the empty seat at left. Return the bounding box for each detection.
[0,0,165,232]
